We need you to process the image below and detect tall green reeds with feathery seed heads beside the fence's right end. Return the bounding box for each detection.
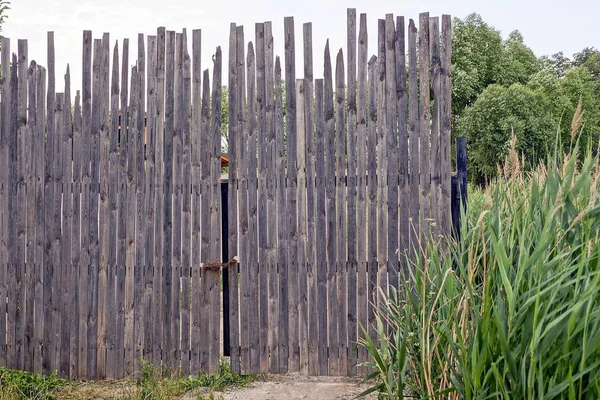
[362,130,600,400]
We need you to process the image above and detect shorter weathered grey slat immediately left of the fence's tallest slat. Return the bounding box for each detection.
[334,49,348,375]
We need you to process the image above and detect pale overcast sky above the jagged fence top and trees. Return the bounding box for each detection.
[3,0,600,95]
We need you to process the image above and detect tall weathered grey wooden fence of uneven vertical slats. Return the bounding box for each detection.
[0,9,454,379]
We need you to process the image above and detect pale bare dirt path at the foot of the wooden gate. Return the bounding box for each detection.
[222,374,376,400]
